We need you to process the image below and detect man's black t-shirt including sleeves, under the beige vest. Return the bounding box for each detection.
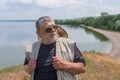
[24,43,85,80]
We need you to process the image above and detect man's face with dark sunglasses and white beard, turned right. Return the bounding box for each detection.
[37,20,58,42]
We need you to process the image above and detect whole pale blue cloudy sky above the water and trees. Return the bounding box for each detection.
[0,0,120,20]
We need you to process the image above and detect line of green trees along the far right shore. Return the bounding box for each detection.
[56,12,120,31]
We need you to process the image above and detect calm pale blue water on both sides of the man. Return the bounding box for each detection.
[0,22,111,69]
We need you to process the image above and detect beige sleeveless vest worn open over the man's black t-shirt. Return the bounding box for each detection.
[26,38,78,80]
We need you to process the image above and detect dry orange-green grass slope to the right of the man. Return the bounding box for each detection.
[80,52,120,80]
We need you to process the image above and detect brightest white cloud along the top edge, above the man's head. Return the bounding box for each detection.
[35,0,88,8]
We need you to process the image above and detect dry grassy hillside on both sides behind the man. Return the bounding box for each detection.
[0,52,120,80]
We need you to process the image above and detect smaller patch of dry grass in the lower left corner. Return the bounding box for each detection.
[0,65,29,80]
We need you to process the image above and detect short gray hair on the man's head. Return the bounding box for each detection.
[36,16,53,30]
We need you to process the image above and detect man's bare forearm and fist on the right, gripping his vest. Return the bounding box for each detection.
[53,57,86,74]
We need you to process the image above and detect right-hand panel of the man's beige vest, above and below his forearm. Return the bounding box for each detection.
[56,38,78,80]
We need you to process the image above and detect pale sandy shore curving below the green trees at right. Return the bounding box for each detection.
[88,27,120,60]
